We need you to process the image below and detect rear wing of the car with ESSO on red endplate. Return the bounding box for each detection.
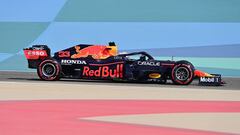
[23,45,51,68]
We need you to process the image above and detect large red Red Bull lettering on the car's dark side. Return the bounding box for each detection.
[82,64,123,78]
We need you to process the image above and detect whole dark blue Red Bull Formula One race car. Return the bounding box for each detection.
[24,42,221,85]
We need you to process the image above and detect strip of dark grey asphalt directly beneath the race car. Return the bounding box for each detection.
[0,71,240,90]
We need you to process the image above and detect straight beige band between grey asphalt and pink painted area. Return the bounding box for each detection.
[0,81,240,101]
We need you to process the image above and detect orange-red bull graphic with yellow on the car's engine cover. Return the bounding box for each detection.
[71,45,117,59]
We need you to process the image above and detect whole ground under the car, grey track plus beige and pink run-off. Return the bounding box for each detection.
[0,72,240,135]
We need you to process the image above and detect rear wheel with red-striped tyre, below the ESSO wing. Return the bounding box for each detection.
[37,59,61,81]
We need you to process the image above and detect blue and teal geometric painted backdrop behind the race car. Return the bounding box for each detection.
[0,0,240,77]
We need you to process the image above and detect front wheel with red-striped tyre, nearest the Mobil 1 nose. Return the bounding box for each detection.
[171,61,195,85]
